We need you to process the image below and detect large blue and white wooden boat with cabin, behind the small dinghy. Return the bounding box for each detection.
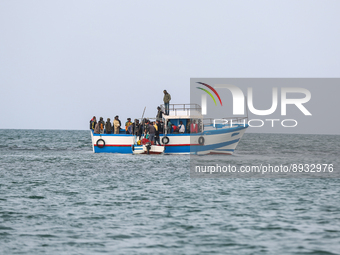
[91,104,248,155]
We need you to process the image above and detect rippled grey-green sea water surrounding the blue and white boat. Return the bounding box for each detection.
[0,130,340,255]
